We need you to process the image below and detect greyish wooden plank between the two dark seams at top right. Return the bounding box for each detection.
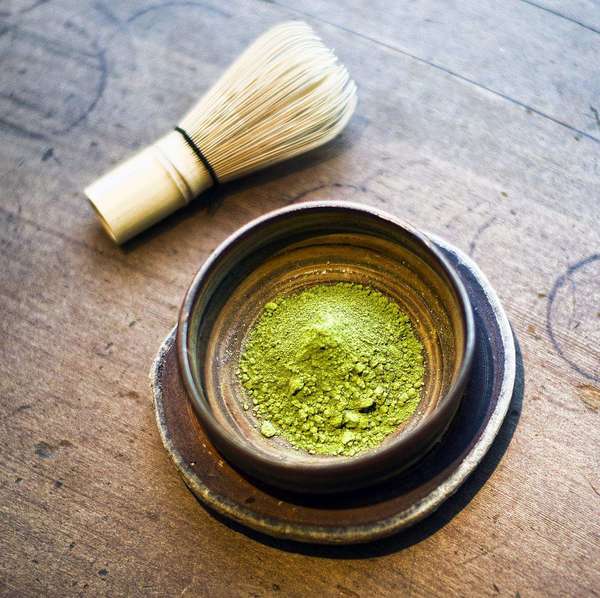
[275,0,600,140]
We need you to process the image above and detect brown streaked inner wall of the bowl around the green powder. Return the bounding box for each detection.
[188,208,466,465]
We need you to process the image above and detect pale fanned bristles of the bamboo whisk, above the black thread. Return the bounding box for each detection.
[180,21,356,181]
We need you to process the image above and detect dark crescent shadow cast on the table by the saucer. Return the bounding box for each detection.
[204,333,525,559]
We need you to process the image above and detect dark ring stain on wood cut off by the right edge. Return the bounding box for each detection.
[546,254,600,382]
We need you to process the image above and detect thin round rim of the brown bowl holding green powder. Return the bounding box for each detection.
[176,200,475,477]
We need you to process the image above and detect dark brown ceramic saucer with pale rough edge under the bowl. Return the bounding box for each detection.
[150,237,515,544]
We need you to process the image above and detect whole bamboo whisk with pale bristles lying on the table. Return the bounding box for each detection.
[85,22,356,243]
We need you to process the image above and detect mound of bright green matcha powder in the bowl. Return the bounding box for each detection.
[239,283,424,455]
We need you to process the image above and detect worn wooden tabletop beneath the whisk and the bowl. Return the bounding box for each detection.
[0,0,600,598]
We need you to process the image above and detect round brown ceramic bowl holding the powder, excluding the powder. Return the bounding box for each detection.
[177,202,475,493]
